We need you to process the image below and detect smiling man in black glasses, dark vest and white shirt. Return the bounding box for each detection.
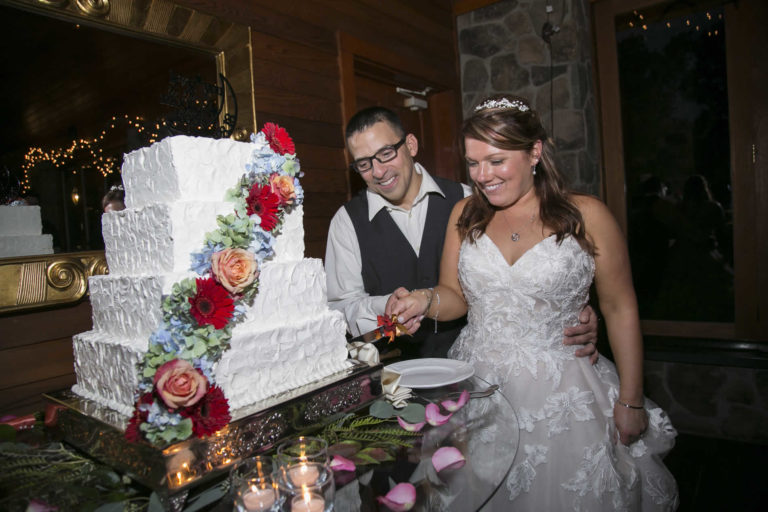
[325,107,597,363]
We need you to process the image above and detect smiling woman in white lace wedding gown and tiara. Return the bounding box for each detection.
[386,96,678,512]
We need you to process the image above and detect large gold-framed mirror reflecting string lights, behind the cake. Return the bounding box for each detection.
[0,0,256,312]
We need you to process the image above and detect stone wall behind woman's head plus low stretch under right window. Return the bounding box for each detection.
[457,0,768,444]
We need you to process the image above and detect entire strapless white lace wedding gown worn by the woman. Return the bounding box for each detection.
[449,235,678,512]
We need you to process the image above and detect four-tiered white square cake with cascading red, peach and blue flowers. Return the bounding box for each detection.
[73,123,349,445]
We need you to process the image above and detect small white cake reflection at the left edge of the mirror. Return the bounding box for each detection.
[0,205,53,258]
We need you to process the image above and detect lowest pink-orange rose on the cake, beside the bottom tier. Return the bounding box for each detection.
[154,359,208,409]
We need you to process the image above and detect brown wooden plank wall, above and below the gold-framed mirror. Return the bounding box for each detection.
[0,0,460,415]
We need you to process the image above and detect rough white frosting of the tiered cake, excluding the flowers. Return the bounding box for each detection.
[72,136,349,415]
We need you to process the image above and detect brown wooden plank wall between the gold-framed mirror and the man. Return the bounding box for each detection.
[176,0,459,258]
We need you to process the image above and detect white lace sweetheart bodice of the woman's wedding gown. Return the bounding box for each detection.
[450,235,595,383]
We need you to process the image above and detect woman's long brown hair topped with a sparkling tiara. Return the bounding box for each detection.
[457,94,593,253]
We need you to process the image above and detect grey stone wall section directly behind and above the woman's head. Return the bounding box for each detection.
[457,0,600,195]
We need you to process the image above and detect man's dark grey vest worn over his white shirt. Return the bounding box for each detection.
[345,177,466,358]
